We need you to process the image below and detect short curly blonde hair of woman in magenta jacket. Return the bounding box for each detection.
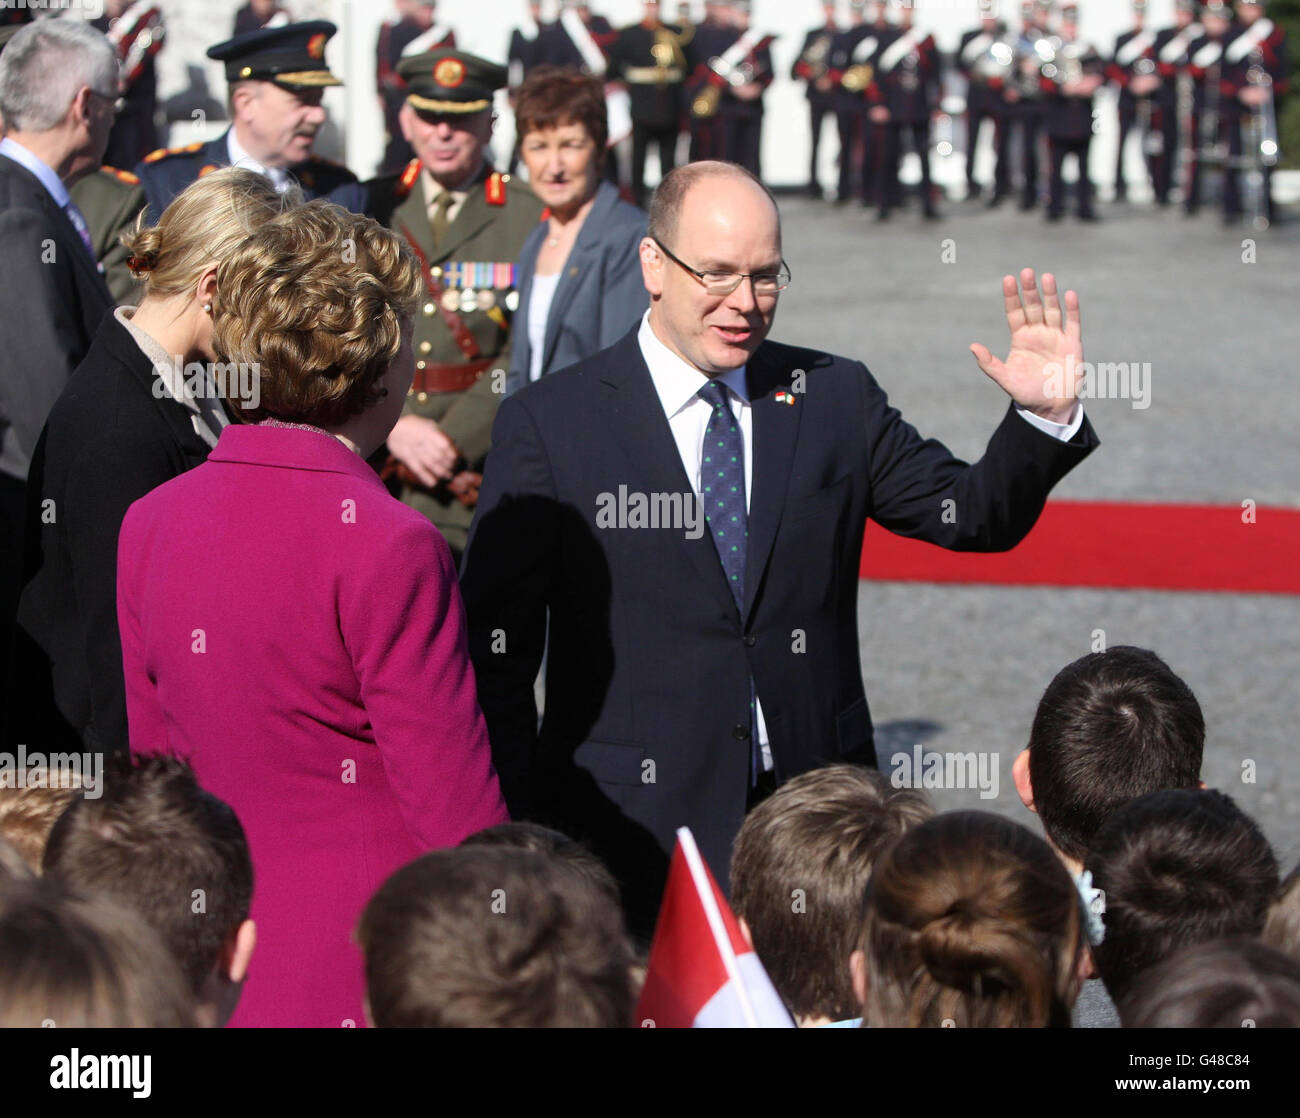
[212,199,421,426]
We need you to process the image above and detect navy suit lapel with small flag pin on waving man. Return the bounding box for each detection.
[743,345,803,618]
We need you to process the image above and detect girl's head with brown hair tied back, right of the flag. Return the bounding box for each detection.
[854,811,1083,1028]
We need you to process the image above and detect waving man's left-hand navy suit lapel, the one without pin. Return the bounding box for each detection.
[601,332,736,611]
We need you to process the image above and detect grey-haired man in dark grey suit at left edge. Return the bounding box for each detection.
[0,20,118,728]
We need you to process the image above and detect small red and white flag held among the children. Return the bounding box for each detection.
[634,827,794,1028]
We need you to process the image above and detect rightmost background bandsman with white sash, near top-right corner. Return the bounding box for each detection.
[1223,0,1291,229]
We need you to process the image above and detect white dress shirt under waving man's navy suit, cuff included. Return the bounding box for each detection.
[637,311,1083,771]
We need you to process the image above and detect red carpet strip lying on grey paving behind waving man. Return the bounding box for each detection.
[861,501,1300,594]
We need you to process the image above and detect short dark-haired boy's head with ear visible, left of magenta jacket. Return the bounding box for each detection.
[44,757,255,1024]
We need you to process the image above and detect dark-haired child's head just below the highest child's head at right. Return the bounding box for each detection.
[1087,789,1278,1005]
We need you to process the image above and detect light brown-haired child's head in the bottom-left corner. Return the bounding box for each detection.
[0,878,195,1028]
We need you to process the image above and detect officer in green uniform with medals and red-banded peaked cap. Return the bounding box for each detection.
[367,49,542,558]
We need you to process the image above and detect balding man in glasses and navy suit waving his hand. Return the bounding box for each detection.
[462,163,1097,933]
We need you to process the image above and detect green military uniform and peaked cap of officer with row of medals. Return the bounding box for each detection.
[365,49,543,556]
